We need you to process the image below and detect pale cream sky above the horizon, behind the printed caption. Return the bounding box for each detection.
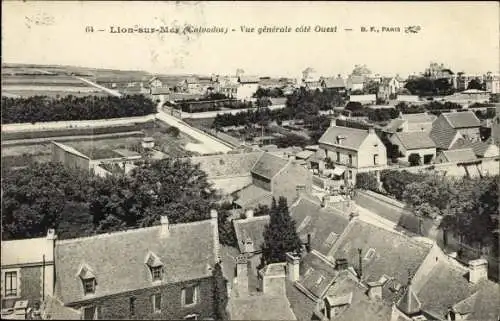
[2,1,500,77]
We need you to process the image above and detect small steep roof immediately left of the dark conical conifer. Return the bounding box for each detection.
[233,215,269,253]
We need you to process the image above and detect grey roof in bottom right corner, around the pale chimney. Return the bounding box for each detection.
[417,261,500,320]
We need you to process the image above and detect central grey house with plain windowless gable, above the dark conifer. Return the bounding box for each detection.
[234,153,312,209]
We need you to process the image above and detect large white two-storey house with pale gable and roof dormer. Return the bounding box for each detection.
[319,125,387,182]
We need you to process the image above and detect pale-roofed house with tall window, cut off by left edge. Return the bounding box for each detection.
[0,230,56,319]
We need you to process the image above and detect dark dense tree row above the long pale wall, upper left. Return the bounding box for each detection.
[2,95,156,124]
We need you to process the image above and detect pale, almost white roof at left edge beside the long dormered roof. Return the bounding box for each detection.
[1,237,54,267]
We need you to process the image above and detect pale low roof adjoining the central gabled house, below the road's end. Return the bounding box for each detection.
[190,152,262,178]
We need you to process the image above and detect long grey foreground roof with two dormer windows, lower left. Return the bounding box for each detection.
[55,220,218,304]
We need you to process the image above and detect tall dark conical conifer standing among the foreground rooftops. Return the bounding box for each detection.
[262,197,302,264]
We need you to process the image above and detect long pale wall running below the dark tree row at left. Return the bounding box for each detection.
[2,114,155,133]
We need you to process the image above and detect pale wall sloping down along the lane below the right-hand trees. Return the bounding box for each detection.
[353,190,433,235]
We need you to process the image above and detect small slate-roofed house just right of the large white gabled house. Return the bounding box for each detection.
[389,132,436,164]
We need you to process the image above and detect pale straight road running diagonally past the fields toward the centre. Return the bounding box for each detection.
[156,100,232,153]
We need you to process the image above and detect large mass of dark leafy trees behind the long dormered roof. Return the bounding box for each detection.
[2,159,218,239]
